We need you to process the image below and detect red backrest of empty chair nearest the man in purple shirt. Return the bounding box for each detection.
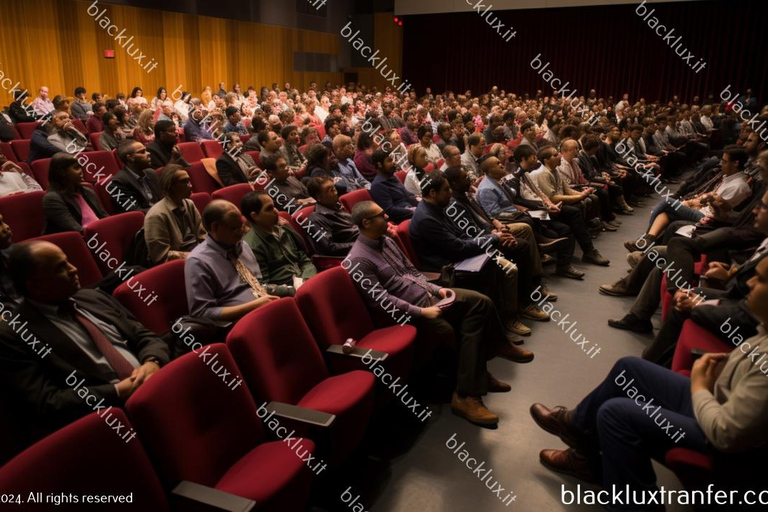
[296,267,374,350]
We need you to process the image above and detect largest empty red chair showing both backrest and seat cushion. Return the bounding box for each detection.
[126,343,315,512]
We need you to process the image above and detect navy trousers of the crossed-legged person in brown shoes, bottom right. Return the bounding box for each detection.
[574,357,709,510]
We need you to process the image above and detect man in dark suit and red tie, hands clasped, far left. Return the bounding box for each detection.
[0,242,170,429]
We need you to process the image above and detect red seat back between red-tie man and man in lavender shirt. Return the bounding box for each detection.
[113,260,189,336]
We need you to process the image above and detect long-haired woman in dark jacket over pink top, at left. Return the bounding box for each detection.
[43,153,109,234]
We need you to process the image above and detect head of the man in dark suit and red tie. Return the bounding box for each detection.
[8,242,80,304]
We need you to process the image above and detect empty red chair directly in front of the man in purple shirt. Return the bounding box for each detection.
[296,267,416,379]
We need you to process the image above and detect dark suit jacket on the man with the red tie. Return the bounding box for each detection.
[0,289,170,428]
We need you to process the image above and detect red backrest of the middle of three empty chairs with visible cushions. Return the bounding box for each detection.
[227,298,328,404]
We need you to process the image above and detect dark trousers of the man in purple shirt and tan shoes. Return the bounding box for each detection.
[416,288,506,396]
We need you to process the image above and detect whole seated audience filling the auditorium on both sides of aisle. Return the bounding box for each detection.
[0,82,768,508]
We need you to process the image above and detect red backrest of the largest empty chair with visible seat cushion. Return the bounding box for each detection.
[126,343,264,487]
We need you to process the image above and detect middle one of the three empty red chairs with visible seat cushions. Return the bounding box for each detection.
[227,298,375,464]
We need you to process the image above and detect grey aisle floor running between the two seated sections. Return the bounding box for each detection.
[370,193,687,512]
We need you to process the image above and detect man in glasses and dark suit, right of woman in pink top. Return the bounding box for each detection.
[109,142,162,213]
